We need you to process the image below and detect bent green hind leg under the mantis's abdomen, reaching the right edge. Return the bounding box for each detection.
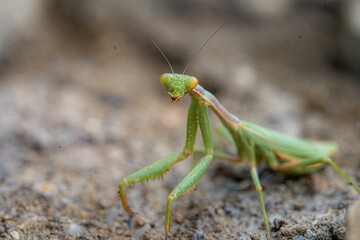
[265,153,360,194]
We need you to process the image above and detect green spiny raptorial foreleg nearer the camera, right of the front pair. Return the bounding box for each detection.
[165,105,214,239]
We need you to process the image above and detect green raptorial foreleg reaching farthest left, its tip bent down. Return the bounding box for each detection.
[119,104,197,214]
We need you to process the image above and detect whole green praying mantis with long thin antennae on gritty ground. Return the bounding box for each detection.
[119,23,360,239]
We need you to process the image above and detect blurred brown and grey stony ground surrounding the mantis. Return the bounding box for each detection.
[0,0,360,239]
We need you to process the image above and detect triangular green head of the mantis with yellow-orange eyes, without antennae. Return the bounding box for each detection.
[160,73,198,101]
